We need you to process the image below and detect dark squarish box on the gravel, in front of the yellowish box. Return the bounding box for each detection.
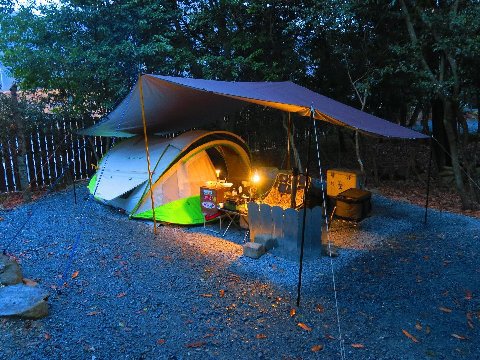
[335,189,372,221]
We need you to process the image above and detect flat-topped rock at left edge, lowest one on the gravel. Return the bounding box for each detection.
[0,284,49,319]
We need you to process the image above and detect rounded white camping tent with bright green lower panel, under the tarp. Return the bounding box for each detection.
[89,130,250,224]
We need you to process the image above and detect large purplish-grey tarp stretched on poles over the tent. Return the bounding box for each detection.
[81,74,428,139]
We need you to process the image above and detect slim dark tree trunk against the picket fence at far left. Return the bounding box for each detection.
[10,84,32,202]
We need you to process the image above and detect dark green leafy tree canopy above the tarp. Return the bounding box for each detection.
[0,0,480,202]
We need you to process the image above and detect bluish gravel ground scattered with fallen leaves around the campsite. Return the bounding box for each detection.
[0,184,480,360]
